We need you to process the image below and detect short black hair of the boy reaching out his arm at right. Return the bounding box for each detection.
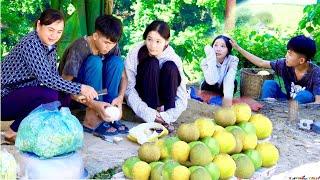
[287,35,317,61]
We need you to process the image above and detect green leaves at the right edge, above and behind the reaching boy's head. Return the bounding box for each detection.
[297,3,320,65]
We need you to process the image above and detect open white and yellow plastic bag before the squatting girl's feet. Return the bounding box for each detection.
[127,122,169,144]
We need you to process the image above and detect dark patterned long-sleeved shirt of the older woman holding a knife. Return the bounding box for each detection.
[1,31,81,97]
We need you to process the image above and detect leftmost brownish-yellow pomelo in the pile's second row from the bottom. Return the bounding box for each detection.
[138,142,161,163]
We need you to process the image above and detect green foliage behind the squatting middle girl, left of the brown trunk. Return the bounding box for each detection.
[115,0,225,81]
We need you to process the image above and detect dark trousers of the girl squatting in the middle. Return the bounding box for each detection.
[135,57,181,110]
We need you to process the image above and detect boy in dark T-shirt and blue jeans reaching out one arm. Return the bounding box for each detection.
[230,35,320,104]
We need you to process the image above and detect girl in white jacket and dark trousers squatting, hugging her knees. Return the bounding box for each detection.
[125,20,188,130]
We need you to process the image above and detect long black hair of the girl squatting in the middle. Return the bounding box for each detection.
[138,20,170,63]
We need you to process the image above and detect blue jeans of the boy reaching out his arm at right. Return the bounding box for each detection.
[261,80,314,104]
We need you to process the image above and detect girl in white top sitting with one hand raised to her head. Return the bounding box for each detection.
[201,35,239,106]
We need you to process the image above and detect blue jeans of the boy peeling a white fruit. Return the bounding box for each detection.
[75,55,124,103]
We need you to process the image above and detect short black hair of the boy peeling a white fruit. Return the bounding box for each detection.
[95,15,123,42]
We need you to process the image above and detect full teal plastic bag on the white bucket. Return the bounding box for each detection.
[15,101,83,158]
